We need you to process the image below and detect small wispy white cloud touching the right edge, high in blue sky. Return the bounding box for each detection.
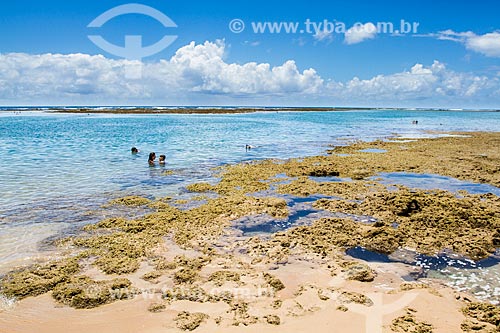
[431,30,500,58]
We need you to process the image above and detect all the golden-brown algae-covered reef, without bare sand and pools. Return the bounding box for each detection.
[0,133,500,316]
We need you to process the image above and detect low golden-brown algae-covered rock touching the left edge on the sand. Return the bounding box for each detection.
[0,259,80,298]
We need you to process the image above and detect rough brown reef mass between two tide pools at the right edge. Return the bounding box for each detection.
[314,187,500,259]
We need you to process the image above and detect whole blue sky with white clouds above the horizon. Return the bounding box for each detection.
[0,0,500,108]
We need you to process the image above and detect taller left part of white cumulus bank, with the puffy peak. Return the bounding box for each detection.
[0,41,323,100]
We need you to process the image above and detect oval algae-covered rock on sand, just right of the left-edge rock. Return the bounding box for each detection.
[52,276,131,309]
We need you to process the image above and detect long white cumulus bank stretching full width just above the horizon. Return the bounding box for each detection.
[0,41,500,105]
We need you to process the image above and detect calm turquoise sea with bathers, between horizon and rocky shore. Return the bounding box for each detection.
[0,111,500,271]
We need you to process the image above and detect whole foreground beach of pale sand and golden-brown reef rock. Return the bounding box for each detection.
[0,132,500,333]
